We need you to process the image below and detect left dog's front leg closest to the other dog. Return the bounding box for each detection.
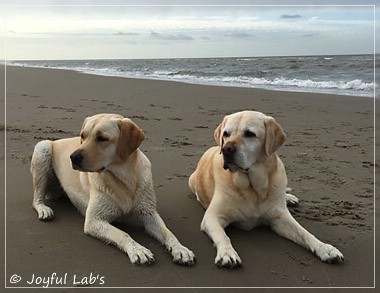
[139,211,195,266]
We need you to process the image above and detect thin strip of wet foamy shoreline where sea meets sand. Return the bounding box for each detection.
[5,64,376,98]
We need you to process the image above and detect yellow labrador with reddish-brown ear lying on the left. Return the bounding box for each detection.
[31,114,194,265]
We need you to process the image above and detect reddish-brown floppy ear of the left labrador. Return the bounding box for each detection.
[117,118,145,161]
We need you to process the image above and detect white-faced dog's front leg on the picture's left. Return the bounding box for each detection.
[201,209,241,268]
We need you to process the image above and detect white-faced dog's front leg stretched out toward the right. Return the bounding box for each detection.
[269,209,344,263]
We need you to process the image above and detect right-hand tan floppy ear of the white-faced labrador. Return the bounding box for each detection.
[264,116,286,156]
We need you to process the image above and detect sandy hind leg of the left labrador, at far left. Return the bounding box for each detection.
[30,140,54,221]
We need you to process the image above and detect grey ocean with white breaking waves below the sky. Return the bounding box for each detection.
[7,55,375,97]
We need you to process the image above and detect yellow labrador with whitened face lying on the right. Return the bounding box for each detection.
[189,111,343,267]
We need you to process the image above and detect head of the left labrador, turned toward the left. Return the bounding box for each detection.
[70,114,144,172]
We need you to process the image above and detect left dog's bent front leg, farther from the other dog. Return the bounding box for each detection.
[84,201,154,265]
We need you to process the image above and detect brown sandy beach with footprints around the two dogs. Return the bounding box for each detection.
[0,66,379,287]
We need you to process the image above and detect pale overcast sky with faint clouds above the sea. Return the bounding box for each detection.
[0,0,380,60]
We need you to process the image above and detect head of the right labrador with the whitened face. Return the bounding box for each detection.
[214,111,285,172]
